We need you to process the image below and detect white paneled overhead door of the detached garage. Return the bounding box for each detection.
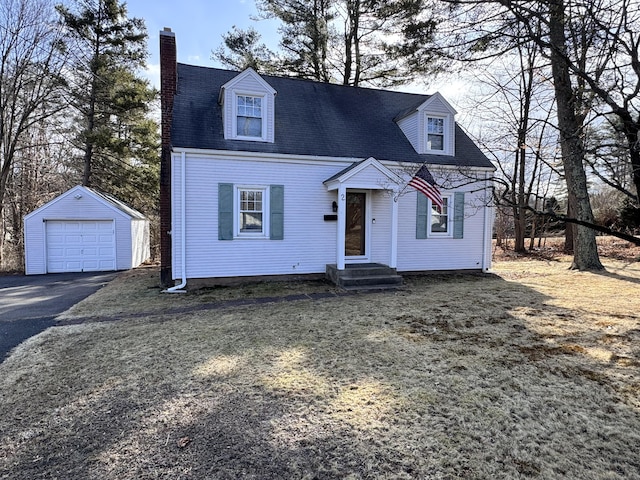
[47,220,116,273]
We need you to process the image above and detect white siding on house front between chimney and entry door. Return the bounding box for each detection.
[172,155,338,278]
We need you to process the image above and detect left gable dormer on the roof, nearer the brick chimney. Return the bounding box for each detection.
[219,68,276,143]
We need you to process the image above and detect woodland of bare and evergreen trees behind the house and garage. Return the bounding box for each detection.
[0,0,640,272]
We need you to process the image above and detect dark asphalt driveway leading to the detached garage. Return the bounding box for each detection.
[0,272,118,362]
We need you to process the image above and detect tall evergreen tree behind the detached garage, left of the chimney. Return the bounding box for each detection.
[58,0,159,210]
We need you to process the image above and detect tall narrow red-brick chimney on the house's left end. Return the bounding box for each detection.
[160,28,172,287]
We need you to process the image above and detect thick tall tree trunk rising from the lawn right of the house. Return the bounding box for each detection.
[549,0,604,270]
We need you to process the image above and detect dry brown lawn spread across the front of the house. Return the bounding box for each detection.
[0,249,640,480]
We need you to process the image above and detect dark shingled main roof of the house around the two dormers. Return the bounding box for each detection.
[171,64,493,168]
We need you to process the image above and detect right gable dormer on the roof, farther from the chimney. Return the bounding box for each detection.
[396,93,457,156]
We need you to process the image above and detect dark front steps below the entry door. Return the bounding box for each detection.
[326,263,402,290]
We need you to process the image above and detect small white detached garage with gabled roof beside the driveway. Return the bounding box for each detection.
[24,186,150,275]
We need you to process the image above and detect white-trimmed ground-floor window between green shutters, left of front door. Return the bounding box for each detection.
[235,187,269,237]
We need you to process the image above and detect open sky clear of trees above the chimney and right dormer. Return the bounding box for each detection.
[125,0,468,103]
